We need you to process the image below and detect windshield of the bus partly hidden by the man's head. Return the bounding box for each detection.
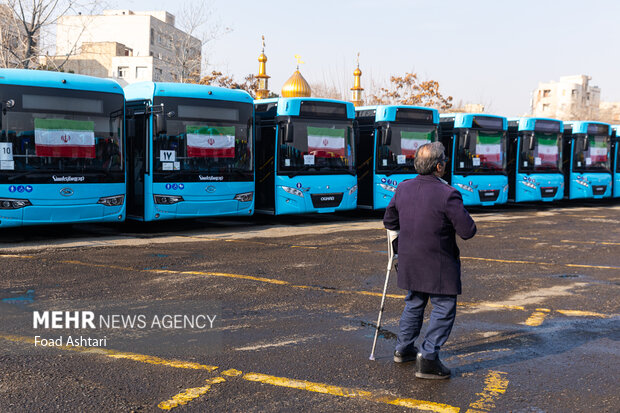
[376,123,437,174]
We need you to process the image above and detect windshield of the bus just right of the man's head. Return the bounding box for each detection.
[454,129,506,173]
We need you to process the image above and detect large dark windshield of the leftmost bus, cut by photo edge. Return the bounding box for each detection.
[0,86,124,182]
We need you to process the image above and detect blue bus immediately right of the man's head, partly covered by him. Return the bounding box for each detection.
[439,113,508,206]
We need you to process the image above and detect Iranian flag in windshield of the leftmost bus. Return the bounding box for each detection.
[34,119,96,159]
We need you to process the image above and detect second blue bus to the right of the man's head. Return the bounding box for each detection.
[507,118,564,202]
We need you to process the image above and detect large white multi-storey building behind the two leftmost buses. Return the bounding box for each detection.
[48,10,202,84]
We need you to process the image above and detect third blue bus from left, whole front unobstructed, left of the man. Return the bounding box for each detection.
[255,98,357,215]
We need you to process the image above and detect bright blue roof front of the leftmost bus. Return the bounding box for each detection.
[0,69,123,95]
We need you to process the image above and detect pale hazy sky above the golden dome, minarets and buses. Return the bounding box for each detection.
[108,0,620,116]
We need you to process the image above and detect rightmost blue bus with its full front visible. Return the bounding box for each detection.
[562,121,611,199]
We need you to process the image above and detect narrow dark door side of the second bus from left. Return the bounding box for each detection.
[127,101,149,220]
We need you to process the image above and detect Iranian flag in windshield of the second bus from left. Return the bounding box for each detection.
[187,126,235,158]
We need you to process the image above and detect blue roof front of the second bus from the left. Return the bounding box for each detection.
[125,82,253,103]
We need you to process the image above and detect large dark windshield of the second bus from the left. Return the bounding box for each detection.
[153,98,253,181]
